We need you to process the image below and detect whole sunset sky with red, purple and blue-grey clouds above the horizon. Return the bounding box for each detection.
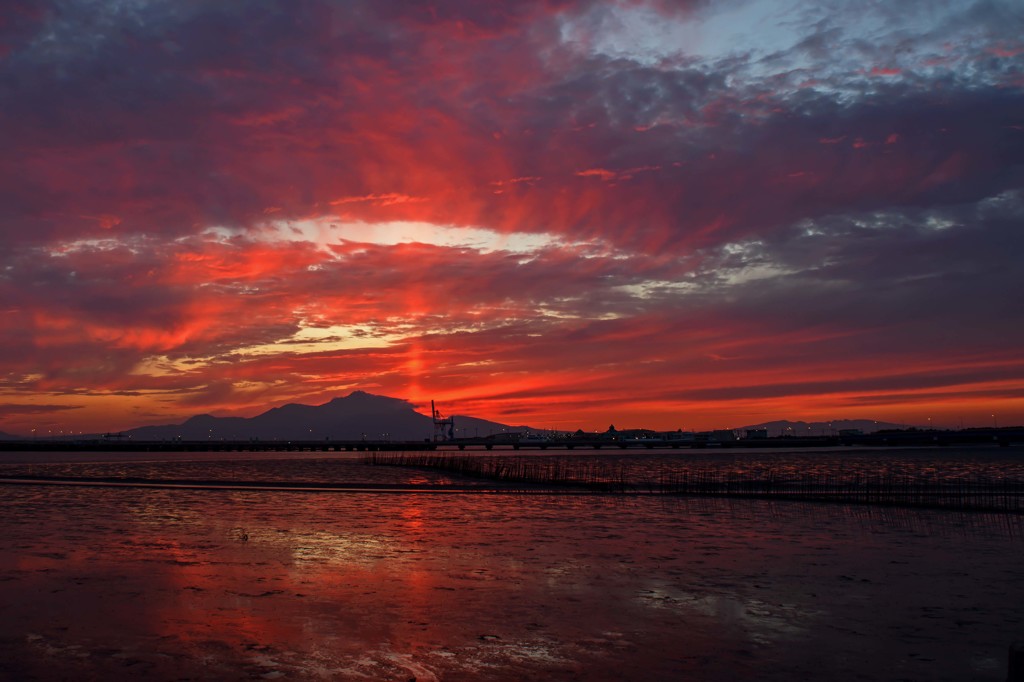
[0,0,1024,434]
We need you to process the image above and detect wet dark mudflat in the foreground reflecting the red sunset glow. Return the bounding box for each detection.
[0,448,1024,682]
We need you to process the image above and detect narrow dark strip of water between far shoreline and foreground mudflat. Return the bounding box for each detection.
[0,446,1024,485]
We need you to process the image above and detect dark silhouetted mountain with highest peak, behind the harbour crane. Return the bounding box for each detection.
[124,391,526,440]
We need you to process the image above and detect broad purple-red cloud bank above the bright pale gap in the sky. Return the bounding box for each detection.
[4,2,1022,247]
